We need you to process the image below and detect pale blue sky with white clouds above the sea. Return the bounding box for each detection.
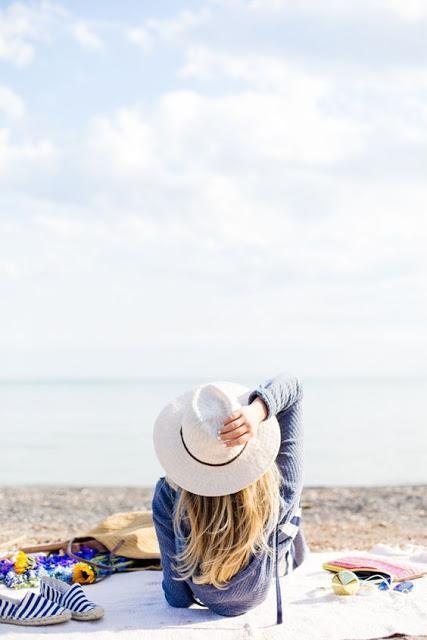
[0,0,427,379]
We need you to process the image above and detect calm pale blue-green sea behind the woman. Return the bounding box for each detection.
[0,378,427,487]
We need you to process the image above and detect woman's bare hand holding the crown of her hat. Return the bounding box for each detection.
[218,398,267,447]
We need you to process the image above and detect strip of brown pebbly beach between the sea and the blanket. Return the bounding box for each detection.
[0,485,427,551]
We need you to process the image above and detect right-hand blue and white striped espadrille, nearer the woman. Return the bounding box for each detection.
[40,576,104,620]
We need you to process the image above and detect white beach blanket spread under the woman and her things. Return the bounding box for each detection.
[0,545,427,640]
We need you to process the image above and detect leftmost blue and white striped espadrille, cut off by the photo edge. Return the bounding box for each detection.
[0,592,71,627]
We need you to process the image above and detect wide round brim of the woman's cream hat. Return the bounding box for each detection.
[153,382,281,496]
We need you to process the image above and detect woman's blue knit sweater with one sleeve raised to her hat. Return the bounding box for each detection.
[152,373,308,616]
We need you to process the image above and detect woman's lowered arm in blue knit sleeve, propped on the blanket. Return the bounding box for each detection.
[151,477,195,607]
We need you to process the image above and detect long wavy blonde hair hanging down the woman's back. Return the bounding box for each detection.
[173,462,283,589]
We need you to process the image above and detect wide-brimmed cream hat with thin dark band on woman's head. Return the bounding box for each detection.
[153,382,281,496]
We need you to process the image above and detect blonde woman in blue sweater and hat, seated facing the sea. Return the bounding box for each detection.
[152,373,308,622]
